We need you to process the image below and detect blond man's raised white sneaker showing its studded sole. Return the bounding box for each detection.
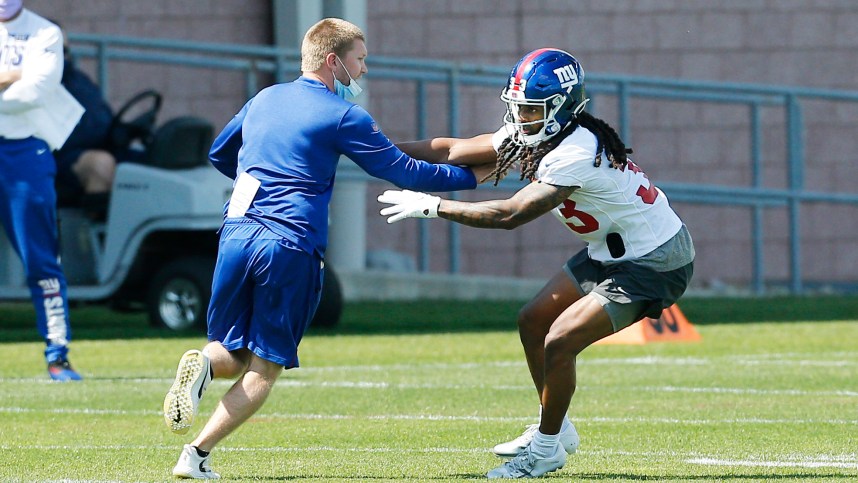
[164,350,212,434]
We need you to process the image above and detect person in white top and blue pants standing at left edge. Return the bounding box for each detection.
[0,0,82,381]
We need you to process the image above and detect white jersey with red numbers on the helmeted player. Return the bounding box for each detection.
[492,126,682,262]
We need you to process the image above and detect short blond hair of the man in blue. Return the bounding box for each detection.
[301,18,366,72]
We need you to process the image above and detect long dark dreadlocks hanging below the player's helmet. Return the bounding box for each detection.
[480,111,632,186]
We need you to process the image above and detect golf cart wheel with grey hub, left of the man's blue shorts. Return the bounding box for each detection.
[146,257,214,330]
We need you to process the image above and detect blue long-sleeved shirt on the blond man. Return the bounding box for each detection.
[209,77,477,256]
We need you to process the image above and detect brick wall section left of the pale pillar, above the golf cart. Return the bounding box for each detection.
[24,0,272,129]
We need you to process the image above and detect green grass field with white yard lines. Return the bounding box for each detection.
[0,297,858,483]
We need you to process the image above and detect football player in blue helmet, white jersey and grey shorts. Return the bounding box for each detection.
[378,48,694,478]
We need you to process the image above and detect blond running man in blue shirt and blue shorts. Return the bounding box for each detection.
[164,18,496,479]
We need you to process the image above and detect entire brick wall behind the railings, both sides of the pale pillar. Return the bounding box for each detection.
[27,0,858,292]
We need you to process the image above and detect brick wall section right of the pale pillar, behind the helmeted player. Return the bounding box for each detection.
[368,0,858,287]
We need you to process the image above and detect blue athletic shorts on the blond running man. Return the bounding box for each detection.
[208,218,324,369]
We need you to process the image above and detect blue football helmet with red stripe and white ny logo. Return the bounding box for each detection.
[494,49,589,146]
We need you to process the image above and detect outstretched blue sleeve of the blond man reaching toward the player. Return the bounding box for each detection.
[337,105,477,191]
